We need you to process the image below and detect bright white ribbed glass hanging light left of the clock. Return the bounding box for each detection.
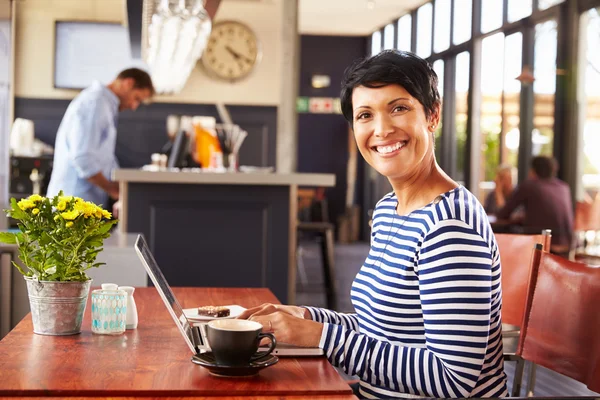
[142,0,212,93]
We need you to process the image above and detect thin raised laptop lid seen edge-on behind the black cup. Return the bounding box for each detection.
[135,235,203,354]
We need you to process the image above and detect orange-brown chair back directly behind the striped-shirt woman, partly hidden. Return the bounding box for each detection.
[495,231,551,326]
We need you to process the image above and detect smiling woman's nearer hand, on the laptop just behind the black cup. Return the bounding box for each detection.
[248,311,323,347]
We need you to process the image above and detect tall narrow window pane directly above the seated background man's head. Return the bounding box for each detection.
[531,20,557,156]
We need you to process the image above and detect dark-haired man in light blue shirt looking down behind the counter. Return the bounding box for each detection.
[47,68,154,205]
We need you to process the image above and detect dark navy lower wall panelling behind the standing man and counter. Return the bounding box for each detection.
[15,97,277,168]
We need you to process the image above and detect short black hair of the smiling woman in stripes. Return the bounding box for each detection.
[340,50,440,124]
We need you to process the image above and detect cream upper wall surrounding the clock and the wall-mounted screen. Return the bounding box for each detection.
[15,0,285,106]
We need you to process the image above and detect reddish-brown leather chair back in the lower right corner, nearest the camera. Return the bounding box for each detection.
[517,245,600,392]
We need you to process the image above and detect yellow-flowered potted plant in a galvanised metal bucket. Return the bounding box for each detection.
[0,192,117,335]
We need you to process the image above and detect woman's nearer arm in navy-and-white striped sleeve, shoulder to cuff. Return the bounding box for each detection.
[320,220,503,397]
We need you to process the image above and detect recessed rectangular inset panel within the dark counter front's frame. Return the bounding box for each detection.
[150,199,270,287]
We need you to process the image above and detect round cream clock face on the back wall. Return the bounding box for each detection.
[202,21,260,81]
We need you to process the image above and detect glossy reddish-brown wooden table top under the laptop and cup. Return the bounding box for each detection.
[0,287,352,398]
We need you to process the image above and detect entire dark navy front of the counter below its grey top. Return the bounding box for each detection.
[127,183,289,302]
